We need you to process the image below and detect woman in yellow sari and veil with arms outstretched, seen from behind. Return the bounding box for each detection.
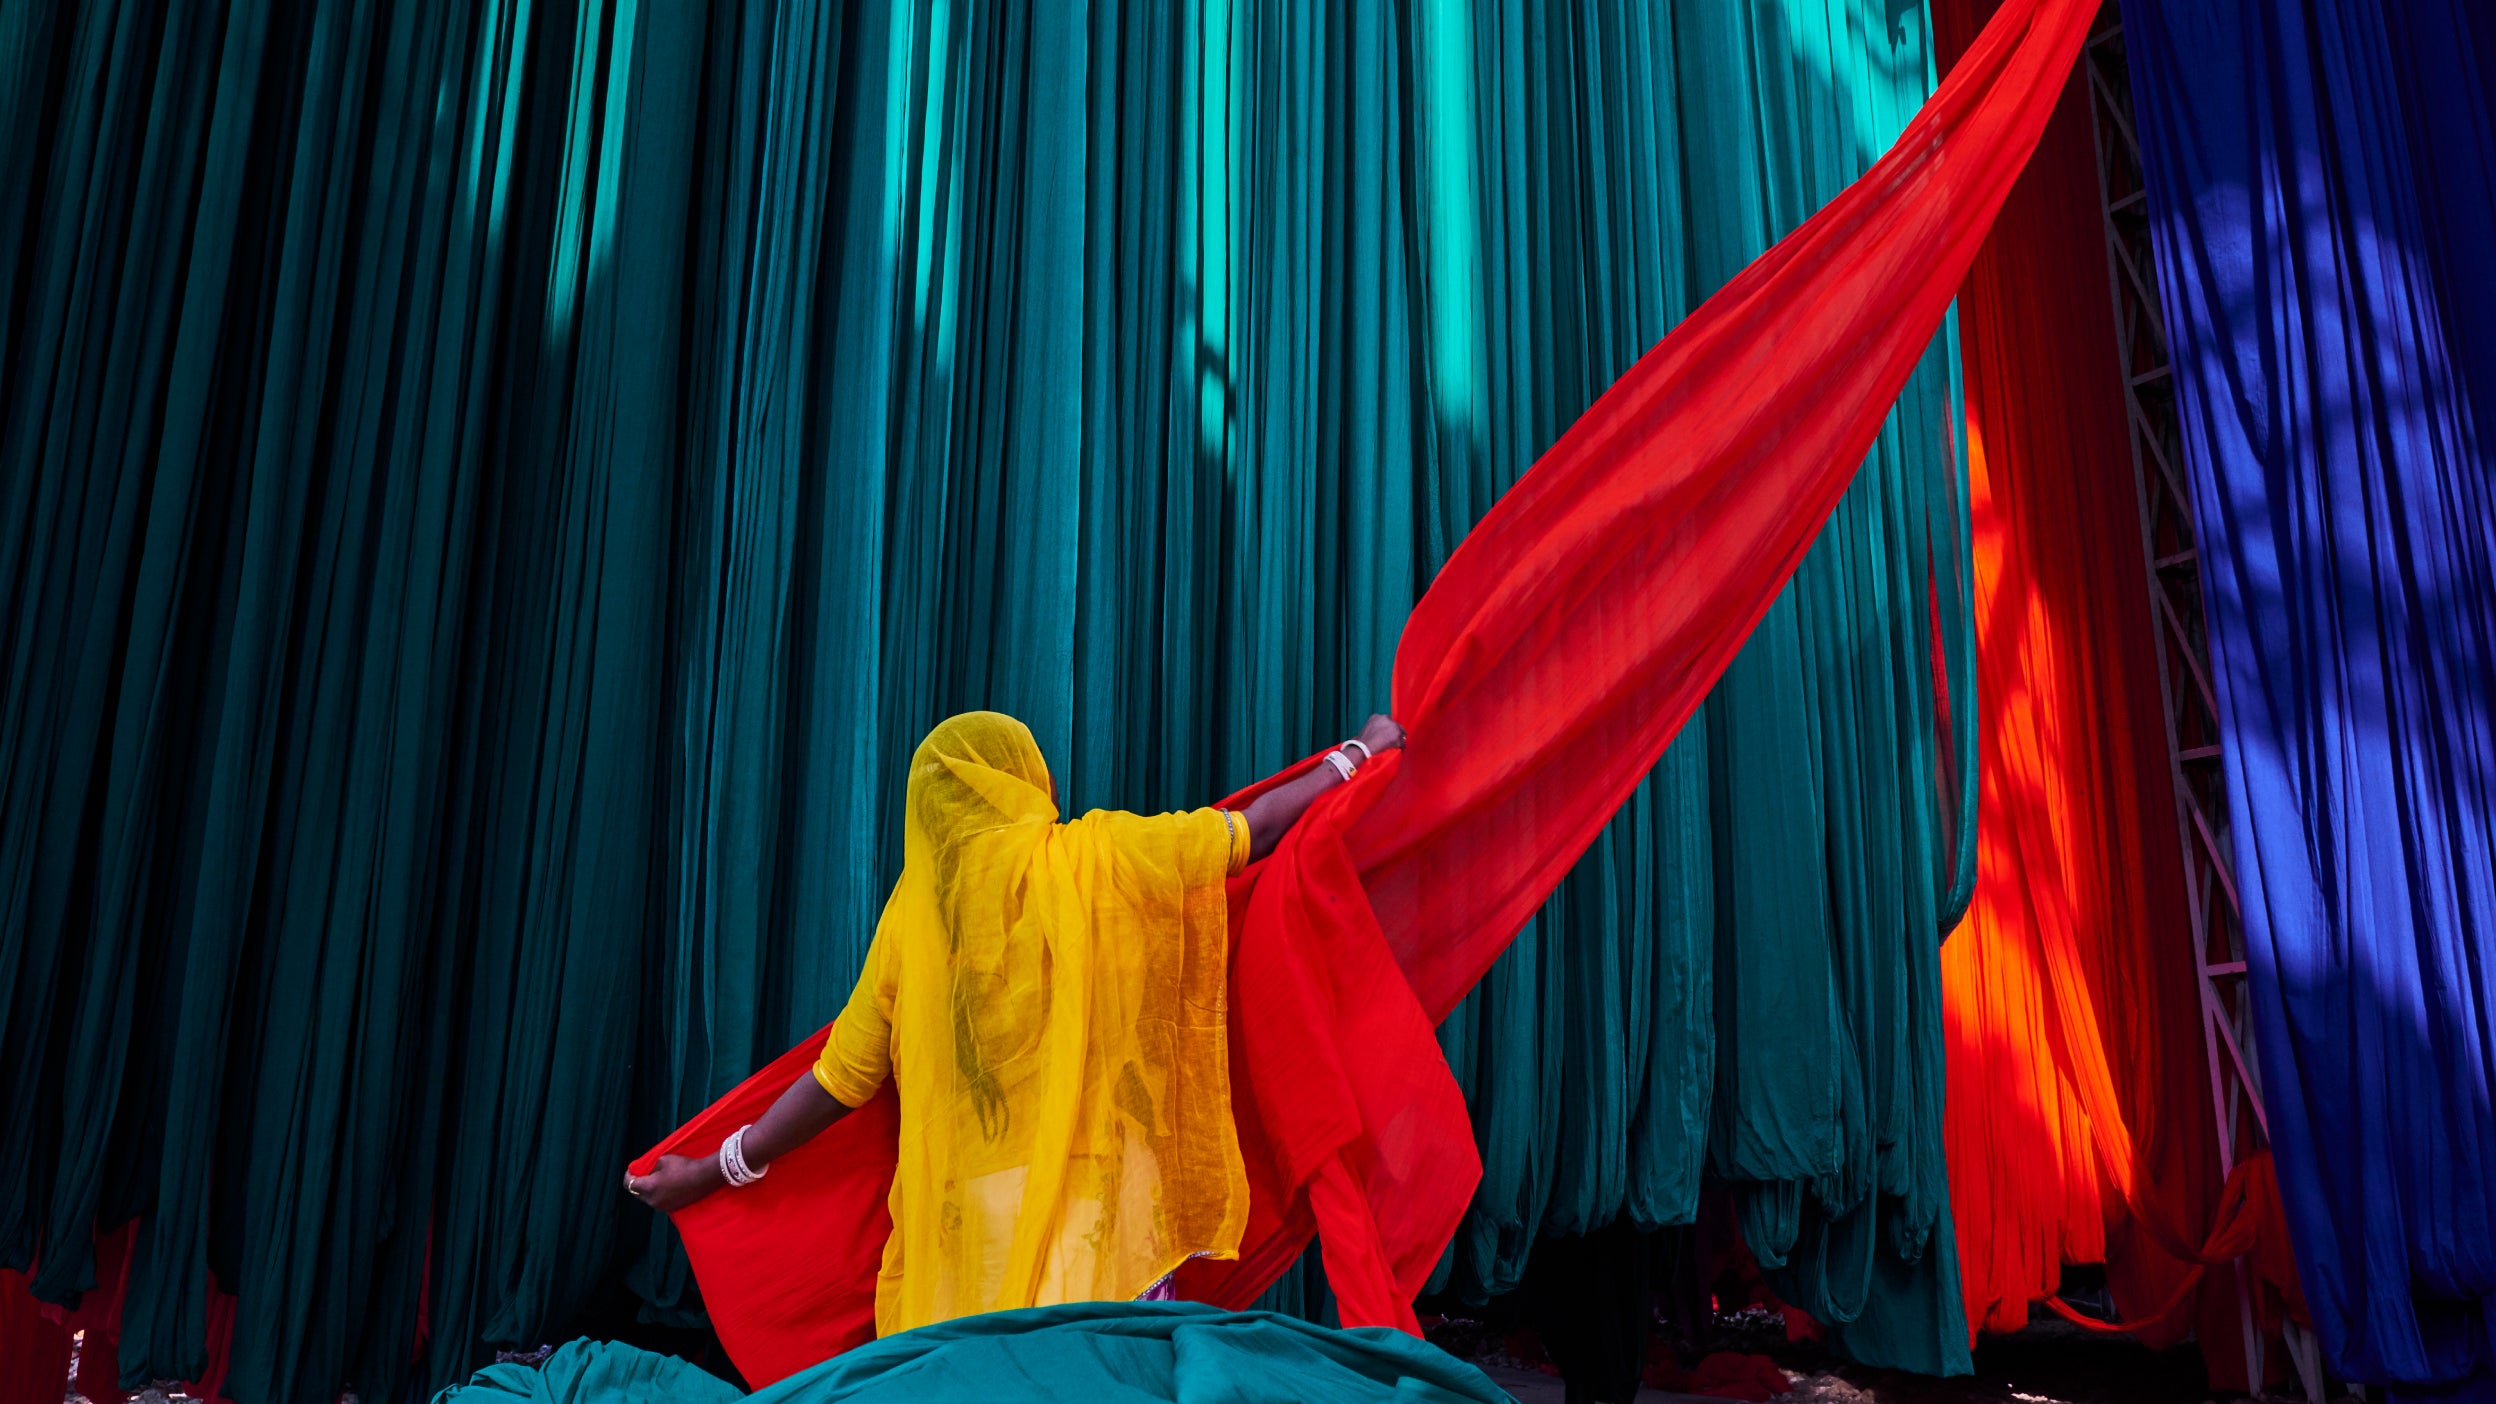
[626,712,1403,1337]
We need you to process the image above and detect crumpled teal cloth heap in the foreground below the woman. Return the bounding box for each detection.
[439,1302,1508,1404]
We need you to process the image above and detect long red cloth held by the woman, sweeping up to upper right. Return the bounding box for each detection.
[636,0,2097,1384]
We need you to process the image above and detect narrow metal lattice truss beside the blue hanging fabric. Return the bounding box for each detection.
[2082,0,2324,1399]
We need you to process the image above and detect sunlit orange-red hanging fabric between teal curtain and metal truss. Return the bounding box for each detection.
[1932,0,2286,1389]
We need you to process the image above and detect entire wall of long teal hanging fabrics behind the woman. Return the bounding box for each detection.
[0,0,1974,1404]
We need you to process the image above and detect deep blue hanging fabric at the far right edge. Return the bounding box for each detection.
[2124,0,2496,1399]
